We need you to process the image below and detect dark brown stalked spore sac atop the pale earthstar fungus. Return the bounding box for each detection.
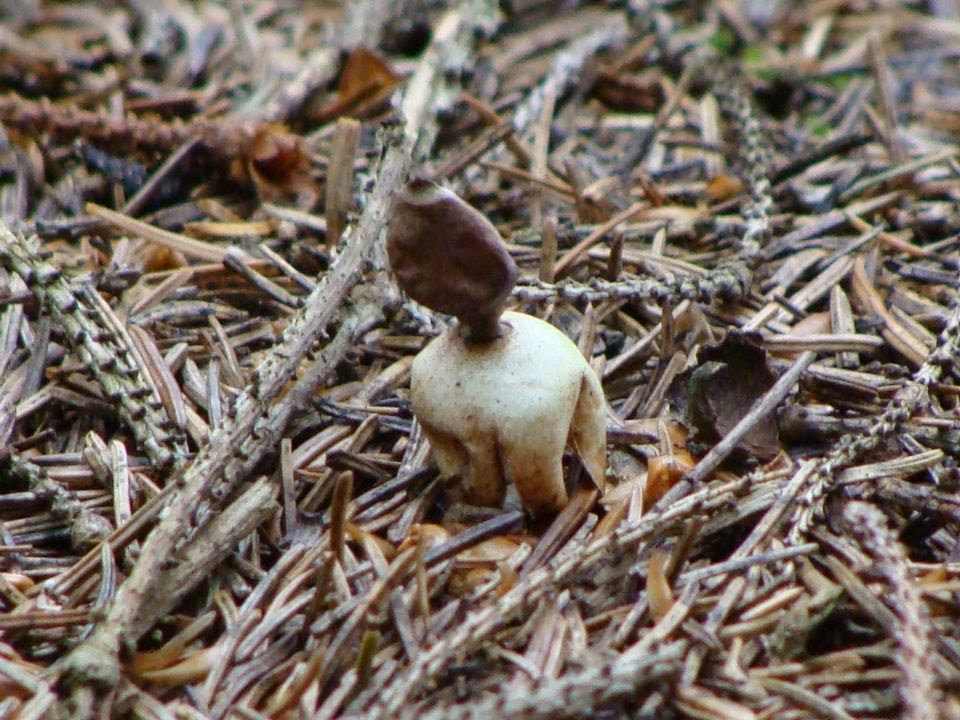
[387,179,517,340]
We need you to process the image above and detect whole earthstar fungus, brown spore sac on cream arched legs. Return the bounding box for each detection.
[387,180,606,516]
